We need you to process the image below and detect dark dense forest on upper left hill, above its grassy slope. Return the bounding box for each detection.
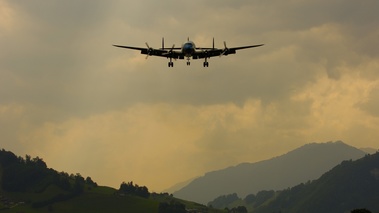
[0,149,97,207]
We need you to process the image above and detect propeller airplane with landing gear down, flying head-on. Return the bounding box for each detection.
[113,38,264,67]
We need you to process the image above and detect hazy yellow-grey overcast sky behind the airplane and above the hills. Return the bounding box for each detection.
[0,0,379,191]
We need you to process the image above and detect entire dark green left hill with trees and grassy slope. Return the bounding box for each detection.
[0,149,223,213]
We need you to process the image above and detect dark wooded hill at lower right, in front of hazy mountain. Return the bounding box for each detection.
[252,152,379,213]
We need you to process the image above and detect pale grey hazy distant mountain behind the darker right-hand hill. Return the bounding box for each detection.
[174,141,365,204]
